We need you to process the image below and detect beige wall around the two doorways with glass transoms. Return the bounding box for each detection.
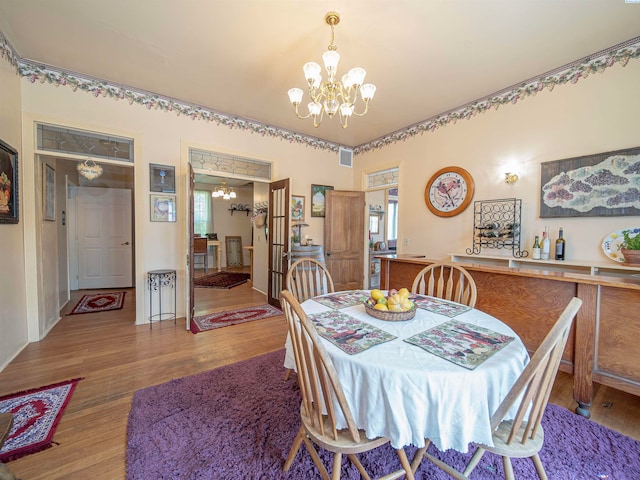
[22,80,353,340]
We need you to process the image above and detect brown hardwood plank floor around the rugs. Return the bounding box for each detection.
[0,276,640,480]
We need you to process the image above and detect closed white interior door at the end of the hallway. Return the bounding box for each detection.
[77,187,133,289]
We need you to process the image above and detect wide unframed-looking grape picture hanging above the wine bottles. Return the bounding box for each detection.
[540,147,640,218]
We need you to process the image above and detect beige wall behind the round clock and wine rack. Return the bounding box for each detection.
[355,61,640,262]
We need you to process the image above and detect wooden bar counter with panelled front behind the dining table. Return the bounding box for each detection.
[380,255,640,418]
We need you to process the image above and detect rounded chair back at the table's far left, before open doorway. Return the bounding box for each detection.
[284,257,334,381]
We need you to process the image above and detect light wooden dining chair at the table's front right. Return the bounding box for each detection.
[411,297,582,480]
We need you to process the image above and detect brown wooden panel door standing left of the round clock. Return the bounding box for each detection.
[324,190,366,291]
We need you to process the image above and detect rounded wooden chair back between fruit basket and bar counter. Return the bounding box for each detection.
[411,263,478,307]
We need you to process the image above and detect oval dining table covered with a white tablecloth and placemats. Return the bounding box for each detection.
[284,290,529,453]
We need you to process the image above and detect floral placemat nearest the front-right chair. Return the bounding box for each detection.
[405,320,513,370]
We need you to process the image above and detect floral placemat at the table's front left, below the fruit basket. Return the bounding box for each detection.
[309,310,396,355]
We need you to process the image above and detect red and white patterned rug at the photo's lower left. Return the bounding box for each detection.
[0,378,82,463]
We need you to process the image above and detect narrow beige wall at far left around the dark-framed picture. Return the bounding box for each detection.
[0,60,27,370]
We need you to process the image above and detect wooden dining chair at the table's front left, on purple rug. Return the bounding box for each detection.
[280,290,414,480]
